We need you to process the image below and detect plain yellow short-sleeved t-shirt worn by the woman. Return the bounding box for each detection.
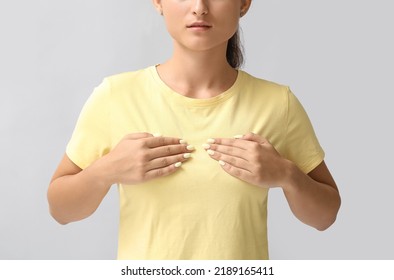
[67,66,324,259]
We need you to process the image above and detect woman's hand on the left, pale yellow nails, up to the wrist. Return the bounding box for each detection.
[96,133,194,185]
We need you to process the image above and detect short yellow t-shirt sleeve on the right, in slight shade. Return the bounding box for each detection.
[285,89,324,174]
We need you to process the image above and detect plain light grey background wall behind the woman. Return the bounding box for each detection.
[0,0,394,259]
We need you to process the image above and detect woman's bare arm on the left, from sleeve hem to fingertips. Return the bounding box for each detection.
[48,133,193,224]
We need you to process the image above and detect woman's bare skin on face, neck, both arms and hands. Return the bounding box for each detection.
[48,0,340,230]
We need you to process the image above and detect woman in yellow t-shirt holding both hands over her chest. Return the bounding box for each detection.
[48,0,340,259]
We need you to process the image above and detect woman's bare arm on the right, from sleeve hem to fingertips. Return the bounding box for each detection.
[202,133,341,230]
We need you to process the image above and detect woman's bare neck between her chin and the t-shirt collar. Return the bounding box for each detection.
[157,41,237,98]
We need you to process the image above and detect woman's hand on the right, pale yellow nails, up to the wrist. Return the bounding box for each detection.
[204,133,289,188]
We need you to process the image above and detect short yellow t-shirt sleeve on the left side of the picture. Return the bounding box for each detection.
[66,79,111,169]
